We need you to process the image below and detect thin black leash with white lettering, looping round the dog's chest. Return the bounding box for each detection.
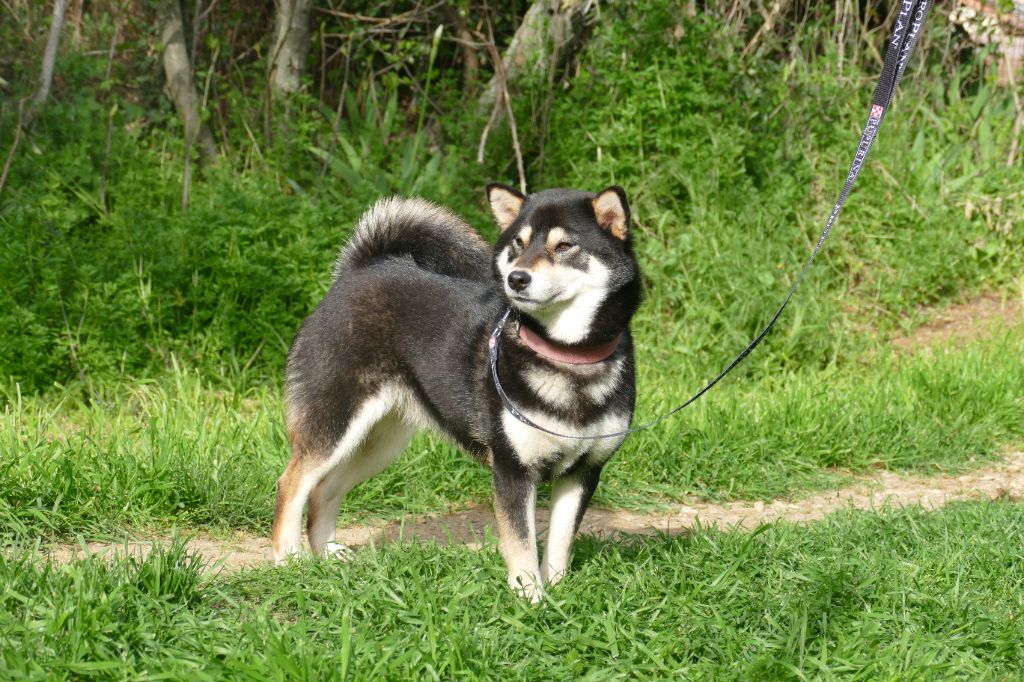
[487,0,932,440]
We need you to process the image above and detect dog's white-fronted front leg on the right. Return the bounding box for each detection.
[541,467,601,585]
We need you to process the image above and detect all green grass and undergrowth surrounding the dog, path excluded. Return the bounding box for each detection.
[0,0,1024,680]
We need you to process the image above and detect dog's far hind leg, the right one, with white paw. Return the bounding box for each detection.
[306,413,415,556]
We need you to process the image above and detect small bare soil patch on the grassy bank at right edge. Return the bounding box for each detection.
[892,294,1024,351]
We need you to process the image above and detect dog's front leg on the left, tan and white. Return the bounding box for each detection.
[494,458,543,602]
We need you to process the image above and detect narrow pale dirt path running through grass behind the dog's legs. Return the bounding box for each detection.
[32,453,1024,570]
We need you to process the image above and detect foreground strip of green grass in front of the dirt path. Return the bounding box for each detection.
[0,503,1024,680]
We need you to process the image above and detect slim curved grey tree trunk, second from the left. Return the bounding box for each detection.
[160,0,217,163]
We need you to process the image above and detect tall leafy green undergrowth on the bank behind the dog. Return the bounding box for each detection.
[0,2,1024,396]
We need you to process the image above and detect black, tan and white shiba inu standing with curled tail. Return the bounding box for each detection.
[272,184,641,600]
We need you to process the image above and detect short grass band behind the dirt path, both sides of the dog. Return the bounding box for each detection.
[0,319,1024,537]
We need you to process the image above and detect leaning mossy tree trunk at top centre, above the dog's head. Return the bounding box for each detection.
[479,0,595,111]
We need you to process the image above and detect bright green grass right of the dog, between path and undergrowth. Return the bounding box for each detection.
[614,311,1024,505]
